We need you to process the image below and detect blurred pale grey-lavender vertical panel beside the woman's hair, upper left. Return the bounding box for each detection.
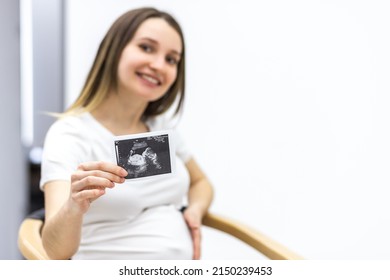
[30,0,64,147]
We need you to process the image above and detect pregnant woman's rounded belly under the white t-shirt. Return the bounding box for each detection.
[72,205,192,260]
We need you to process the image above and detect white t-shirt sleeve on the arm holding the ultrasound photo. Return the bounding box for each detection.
[39,117,89,190]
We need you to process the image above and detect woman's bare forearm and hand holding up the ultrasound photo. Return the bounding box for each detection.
[42,162,127,259]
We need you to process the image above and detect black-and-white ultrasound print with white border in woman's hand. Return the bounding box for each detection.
[114,131,173,179]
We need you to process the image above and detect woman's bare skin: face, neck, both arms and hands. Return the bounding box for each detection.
[42,18,213,259]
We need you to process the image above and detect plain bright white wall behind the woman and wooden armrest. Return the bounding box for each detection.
[65,0,390,259]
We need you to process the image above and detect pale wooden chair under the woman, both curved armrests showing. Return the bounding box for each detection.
[18,209,303,260]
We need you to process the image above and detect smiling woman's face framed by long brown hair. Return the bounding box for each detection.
[118,18,182,102]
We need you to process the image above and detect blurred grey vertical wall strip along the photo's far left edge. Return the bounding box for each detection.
[0,0,27,260]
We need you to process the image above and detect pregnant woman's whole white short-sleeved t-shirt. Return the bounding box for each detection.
[40,113,192,260]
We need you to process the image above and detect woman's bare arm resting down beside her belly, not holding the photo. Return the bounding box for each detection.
[184,159,213,259]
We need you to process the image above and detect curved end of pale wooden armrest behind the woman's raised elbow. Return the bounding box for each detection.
[18,218,49,260]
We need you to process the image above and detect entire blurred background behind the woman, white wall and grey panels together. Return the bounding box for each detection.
[0,0,390,260]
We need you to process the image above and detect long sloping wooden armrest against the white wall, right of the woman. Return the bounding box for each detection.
[202,213,303,260]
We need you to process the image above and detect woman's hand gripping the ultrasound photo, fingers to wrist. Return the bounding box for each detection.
[69,161,127,213]
